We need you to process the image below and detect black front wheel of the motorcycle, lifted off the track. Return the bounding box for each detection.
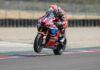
[34,34,43,53]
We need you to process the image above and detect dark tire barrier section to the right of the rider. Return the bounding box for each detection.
[69,19,100,27]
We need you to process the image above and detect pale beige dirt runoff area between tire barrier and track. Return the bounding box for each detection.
[0,27,100,48]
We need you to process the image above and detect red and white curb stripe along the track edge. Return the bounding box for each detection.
[0,49,100,59]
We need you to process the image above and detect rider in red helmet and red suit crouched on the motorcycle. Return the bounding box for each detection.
[48,5,68,42]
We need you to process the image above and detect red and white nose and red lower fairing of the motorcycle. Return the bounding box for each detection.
[38,17,59,48]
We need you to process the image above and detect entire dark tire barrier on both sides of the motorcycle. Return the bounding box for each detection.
[0,19,100,27]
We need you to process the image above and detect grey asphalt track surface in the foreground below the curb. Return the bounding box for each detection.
[0,51,100,70]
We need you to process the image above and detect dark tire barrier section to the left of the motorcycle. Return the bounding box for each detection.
[0,19,37,27]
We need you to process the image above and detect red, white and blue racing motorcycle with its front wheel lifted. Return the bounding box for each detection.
[34,13,66,55]
